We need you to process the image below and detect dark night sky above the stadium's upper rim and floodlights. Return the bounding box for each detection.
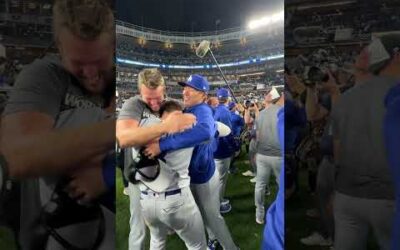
[116,0,284,32]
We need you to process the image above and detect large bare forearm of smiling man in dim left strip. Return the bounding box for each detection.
[1,112,115,178]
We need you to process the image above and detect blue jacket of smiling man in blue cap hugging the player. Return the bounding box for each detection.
[160,103,217,184]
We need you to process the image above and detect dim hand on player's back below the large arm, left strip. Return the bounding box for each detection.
[65,165,107,203]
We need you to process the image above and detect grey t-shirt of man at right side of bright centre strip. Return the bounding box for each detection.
[255,105,282,156]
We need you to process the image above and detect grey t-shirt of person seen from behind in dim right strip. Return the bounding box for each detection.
[332,77,398,199]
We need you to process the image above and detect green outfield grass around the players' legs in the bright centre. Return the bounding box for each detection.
[116,149,277,250]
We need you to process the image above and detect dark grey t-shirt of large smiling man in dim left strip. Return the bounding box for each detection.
[3,57,106,249]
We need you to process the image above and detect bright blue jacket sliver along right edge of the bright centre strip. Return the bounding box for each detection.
[262,108,285,250]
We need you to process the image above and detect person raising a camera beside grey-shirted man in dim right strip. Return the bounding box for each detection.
[286,55,347,245]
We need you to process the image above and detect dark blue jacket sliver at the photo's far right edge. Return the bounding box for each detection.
[384,84,400,250]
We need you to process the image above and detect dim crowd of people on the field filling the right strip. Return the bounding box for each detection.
[285,34,400,249]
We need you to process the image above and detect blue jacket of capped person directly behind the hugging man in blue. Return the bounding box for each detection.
[214,104,236,159]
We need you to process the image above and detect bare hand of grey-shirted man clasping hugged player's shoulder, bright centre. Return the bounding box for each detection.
[163,111,196,134]
